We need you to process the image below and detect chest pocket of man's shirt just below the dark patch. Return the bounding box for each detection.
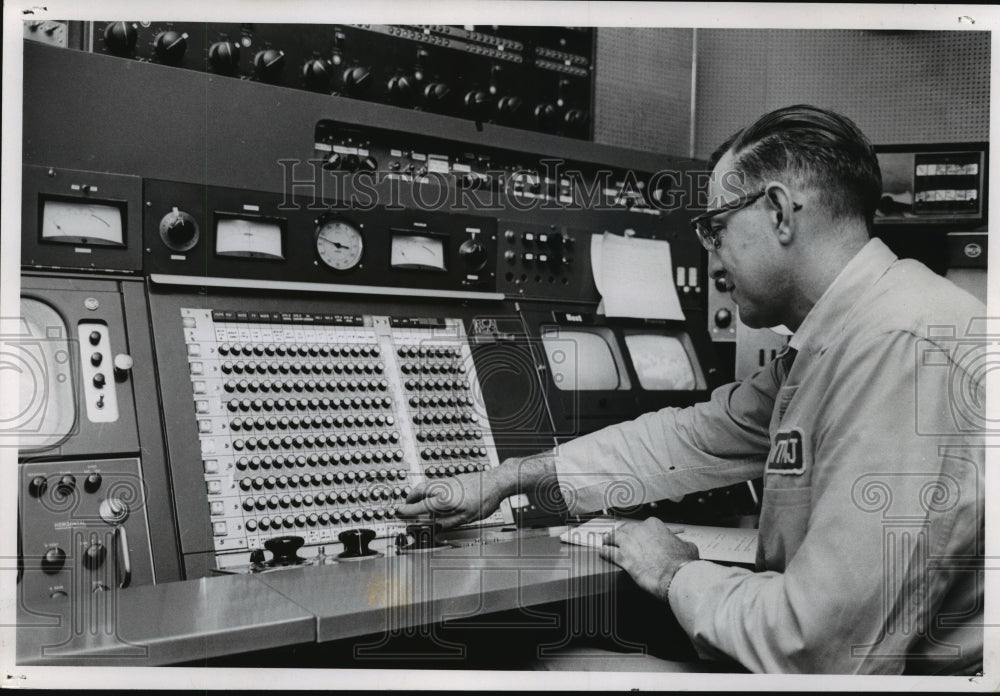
[757,484,812,571]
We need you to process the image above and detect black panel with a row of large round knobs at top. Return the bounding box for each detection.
[91,21,594,138]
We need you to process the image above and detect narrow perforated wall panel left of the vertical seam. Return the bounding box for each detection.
[594,27,693,155]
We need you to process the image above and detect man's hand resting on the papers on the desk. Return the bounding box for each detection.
[600,517,699,602]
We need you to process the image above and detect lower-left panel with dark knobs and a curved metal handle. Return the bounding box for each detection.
[20,458,153,608]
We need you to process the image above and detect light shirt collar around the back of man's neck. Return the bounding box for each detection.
[788,238,897,353]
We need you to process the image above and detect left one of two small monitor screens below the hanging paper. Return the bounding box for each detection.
[542,327,629,391]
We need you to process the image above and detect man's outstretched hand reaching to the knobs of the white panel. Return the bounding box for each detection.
[396,471,505,529]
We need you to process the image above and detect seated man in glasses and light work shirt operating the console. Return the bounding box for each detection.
[400,105,985,674]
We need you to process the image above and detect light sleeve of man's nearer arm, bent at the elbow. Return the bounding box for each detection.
[669,333,982,673]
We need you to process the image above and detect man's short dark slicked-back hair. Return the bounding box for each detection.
[710,104,882,231]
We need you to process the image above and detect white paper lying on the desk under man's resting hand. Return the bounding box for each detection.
[559,517,757,565]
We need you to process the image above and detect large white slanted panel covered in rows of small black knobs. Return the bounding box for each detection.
[181,308,512,568]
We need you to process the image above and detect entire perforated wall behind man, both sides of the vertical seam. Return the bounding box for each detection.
[594,28,990,158]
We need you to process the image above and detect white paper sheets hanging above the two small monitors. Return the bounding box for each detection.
[590,232,684,320]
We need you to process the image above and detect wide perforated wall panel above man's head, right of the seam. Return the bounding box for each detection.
[696,29,990,157]
